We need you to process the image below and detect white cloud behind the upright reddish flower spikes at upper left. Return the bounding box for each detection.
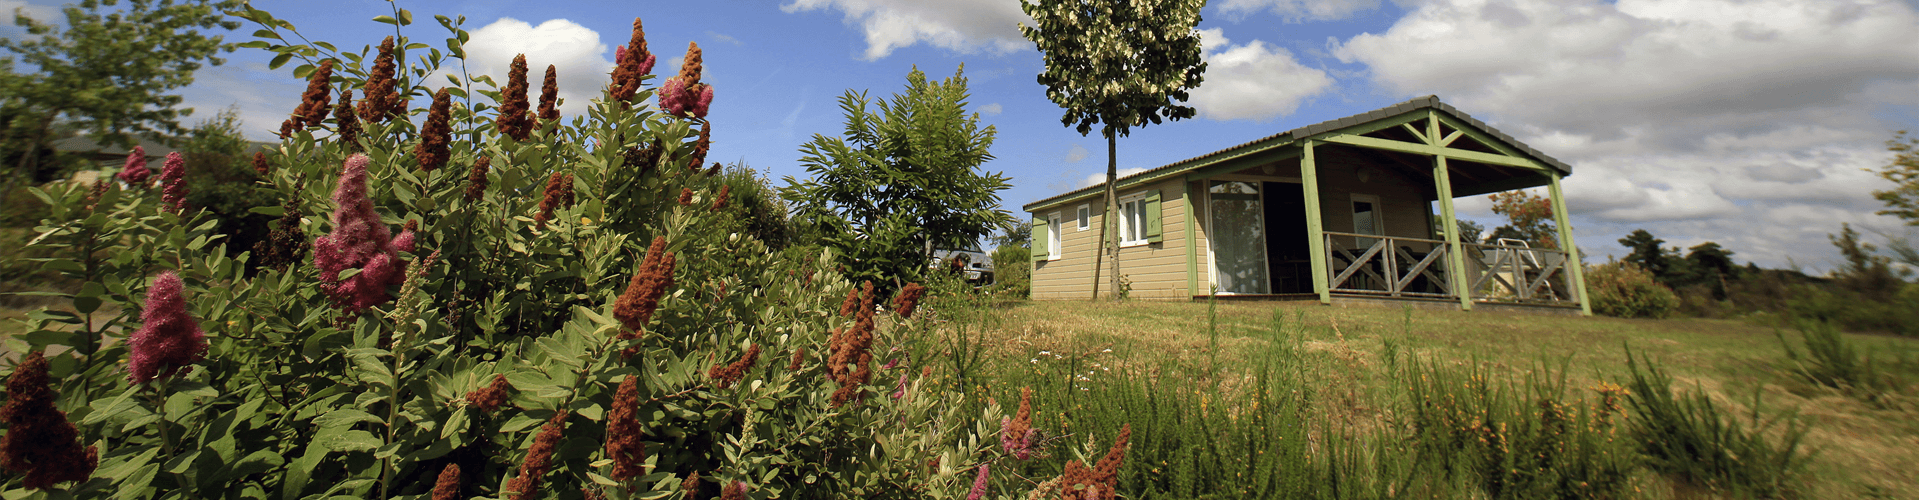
[426,17,614,117]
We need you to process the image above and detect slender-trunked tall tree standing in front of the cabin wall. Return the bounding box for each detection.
[1019,0,1205,299]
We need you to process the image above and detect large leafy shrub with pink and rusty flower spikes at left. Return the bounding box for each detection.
[0,8,1051,500]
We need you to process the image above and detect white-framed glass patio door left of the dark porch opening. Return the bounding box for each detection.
[1207,180,1272,293]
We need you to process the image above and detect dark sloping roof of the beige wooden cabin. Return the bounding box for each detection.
[1021,96,1572,211]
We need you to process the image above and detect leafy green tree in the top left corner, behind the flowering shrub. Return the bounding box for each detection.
[0,0,242,203]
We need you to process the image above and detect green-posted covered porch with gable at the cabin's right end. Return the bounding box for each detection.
[1180,98,1591,314]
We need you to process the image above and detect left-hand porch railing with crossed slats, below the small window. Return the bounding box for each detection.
[1324,232,1458,299]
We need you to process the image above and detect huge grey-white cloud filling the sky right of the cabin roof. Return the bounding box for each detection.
[1332,0,1919,268]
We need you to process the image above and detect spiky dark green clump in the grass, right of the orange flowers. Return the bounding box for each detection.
[1625,351,1806,498]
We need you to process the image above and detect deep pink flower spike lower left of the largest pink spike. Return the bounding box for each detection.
[127,270,207,385]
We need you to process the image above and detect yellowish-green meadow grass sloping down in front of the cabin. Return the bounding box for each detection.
[963,301,1919,498]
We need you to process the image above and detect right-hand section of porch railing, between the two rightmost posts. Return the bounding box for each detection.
[1464,239,1575,305]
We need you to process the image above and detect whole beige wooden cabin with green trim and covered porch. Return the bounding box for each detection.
[1025,96,1591,314]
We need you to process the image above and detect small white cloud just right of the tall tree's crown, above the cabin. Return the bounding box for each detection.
[1190,29,1334,121]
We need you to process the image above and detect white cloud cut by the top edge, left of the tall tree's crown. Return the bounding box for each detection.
[779,0,1032,61]
